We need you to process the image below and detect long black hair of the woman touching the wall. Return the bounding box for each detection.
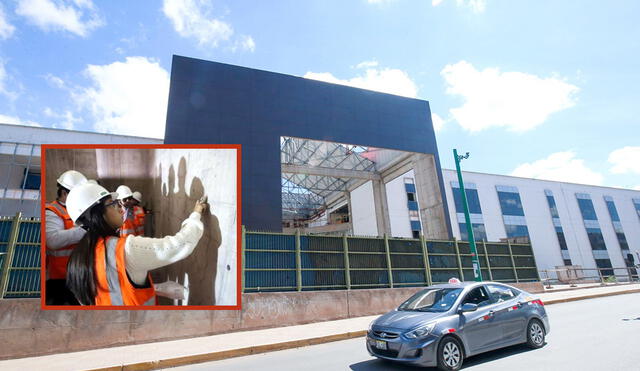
[67,196,117,305]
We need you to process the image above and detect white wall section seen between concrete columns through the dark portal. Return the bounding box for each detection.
[386,170,415,238]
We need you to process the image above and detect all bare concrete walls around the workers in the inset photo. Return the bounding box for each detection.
[45,148,238,305]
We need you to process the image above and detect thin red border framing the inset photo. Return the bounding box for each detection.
[40,144,242,310]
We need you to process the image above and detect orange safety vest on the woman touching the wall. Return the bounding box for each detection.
[94,236,156,305]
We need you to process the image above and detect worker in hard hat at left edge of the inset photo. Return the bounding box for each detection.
[45,170,87,305]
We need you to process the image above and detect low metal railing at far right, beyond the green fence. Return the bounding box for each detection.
[540,265,640,288]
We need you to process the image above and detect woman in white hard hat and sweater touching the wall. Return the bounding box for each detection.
[67,183,208,306]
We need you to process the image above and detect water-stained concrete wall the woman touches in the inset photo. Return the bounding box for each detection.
[151,149,238,305]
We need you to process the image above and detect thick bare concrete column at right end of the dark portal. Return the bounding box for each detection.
[412,153,449,240]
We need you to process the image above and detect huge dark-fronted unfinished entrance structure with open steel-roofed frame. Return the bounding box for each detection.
[165,56,451,239]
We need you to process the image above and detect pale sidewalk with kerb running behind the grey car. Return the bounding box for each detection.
[0,284,640,371]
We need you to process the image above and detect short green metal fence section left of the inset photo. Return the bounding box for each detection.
[0,213,40,298]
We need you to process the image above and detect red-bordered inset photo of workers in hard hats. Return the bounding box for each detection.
[41,145,241,309]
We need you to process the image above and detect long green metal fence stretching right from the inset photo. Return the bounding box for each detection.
[242,228,540,292]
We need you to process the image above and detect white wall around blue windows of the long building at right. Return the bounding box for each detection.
[443,170,640,269]
